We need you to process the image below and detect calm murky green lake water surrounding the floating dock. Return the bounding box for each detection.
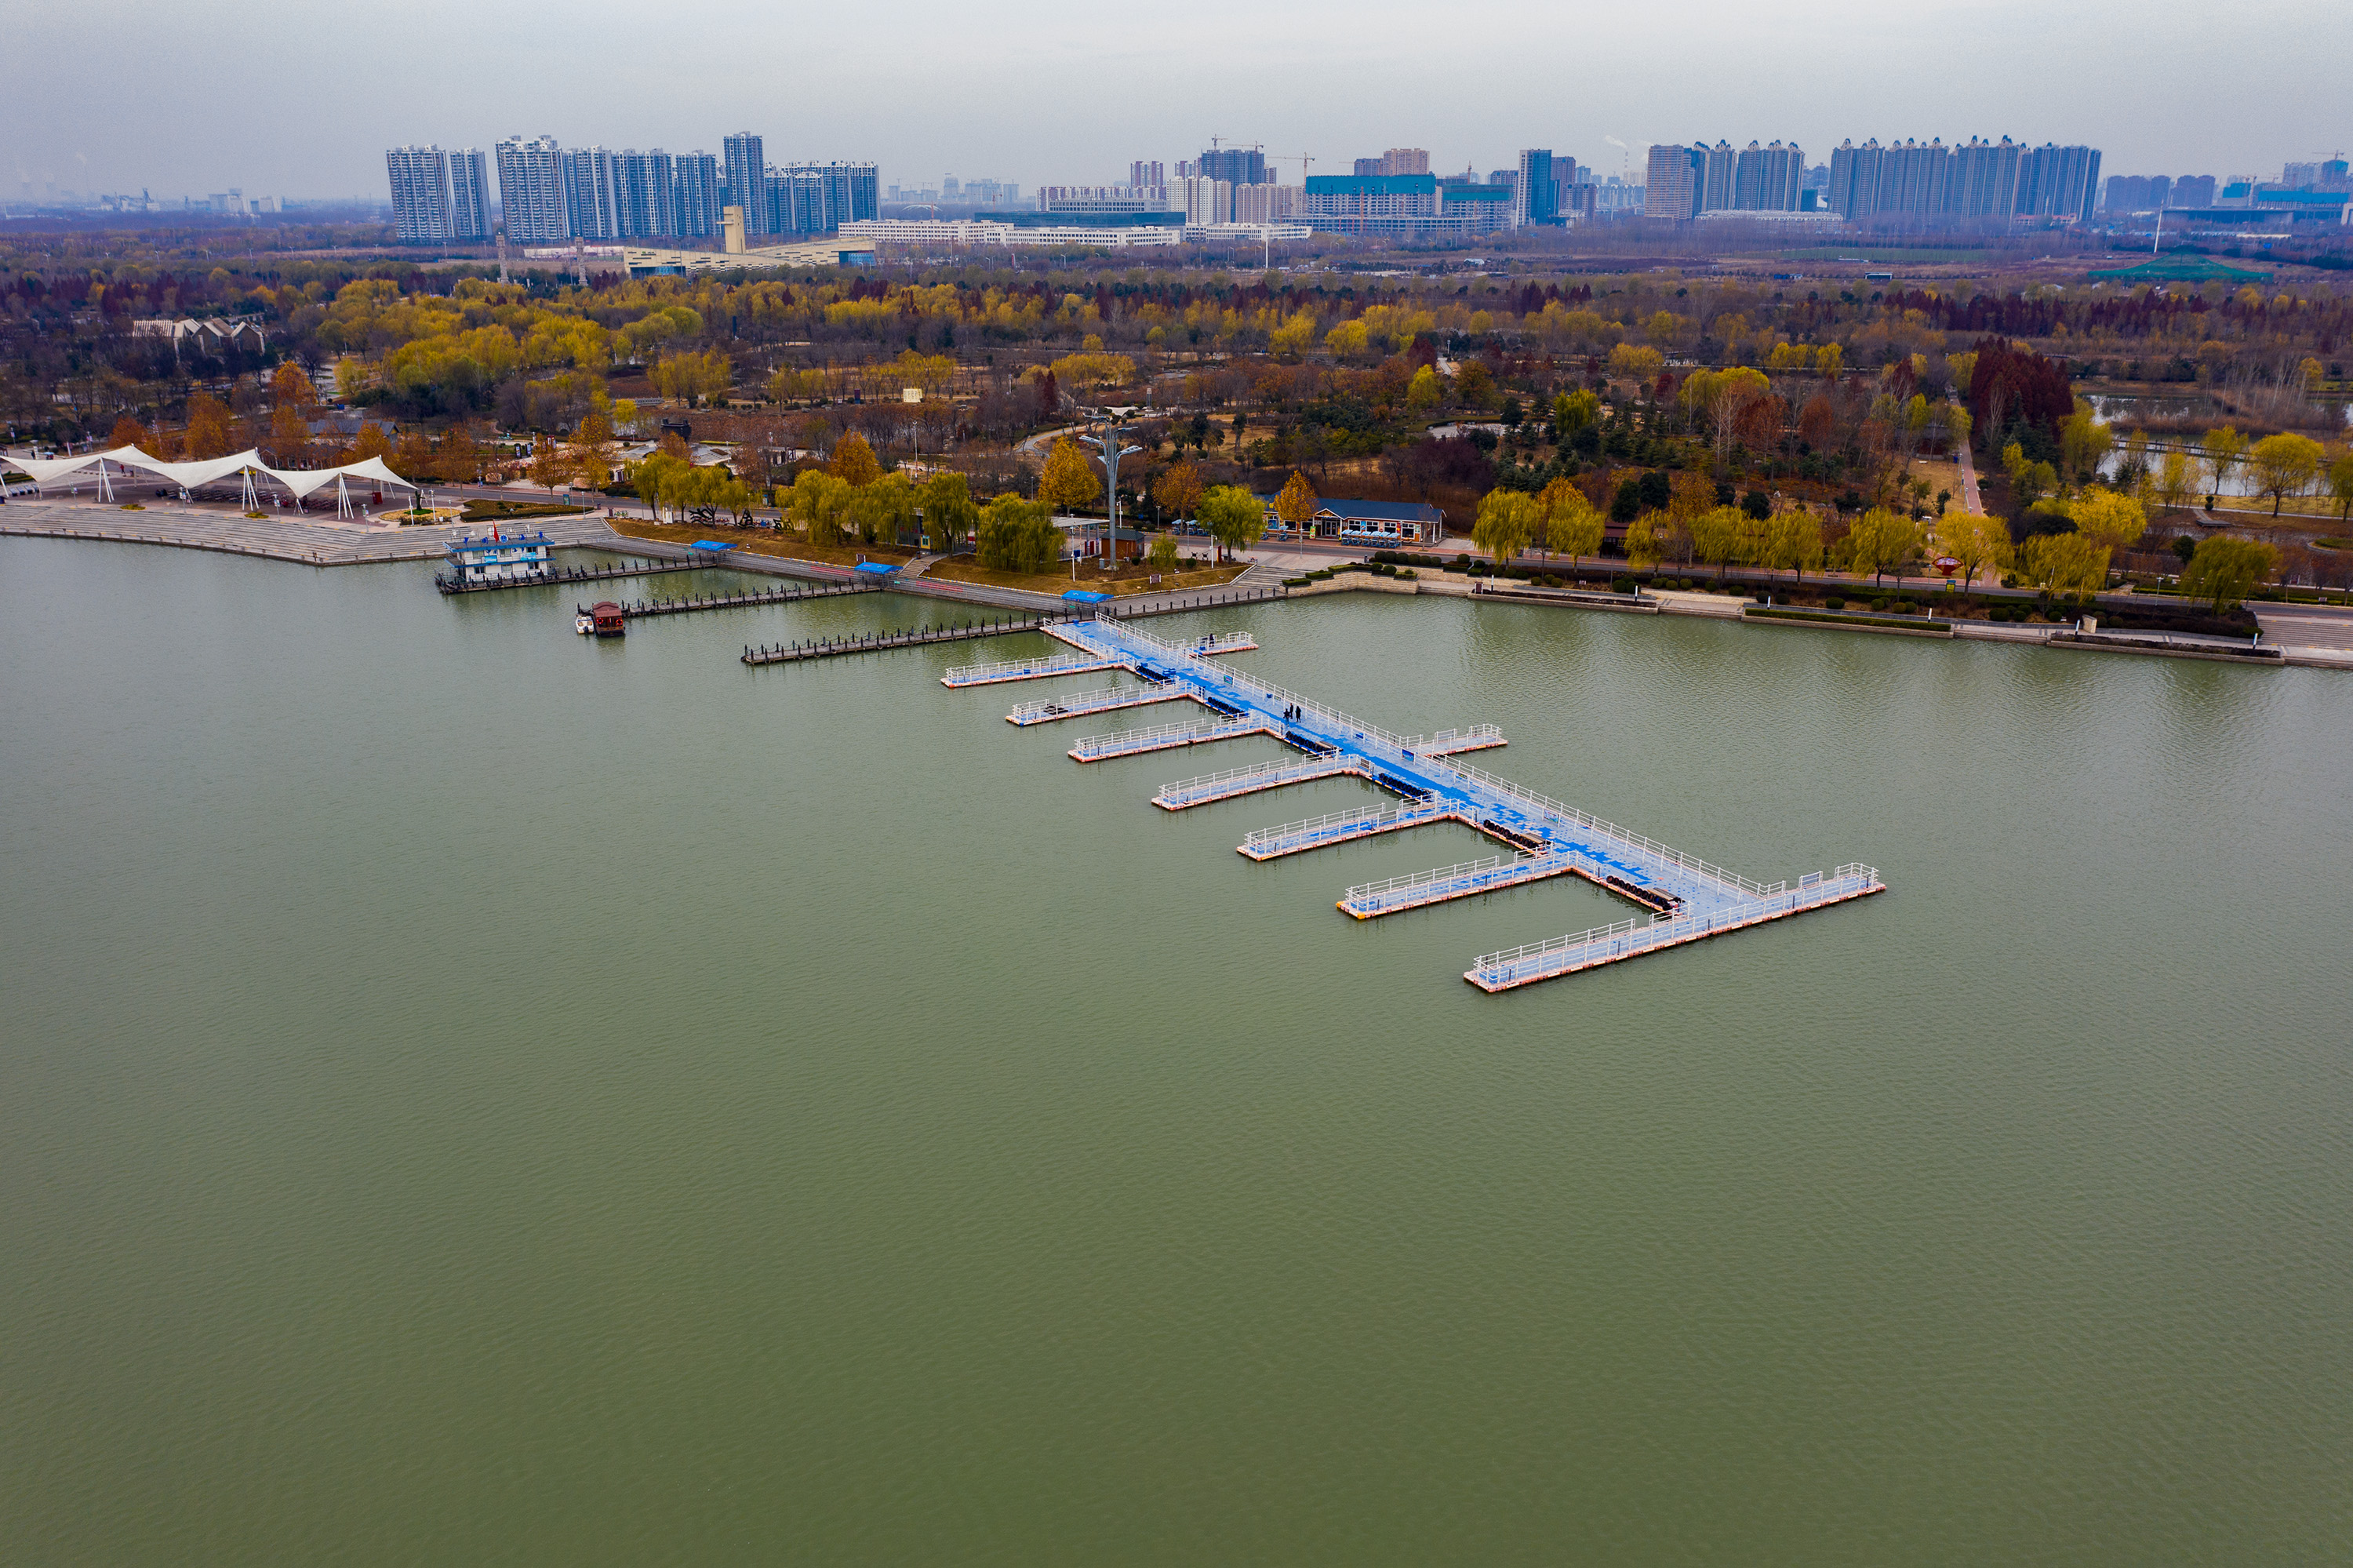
[0,539,2353,1563]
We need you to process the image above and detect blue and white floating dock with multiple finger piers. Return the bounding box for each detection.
[948,617,1885,991]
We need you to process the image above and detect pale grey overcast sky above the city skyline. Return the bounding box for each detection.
[18,0,2353,198]
